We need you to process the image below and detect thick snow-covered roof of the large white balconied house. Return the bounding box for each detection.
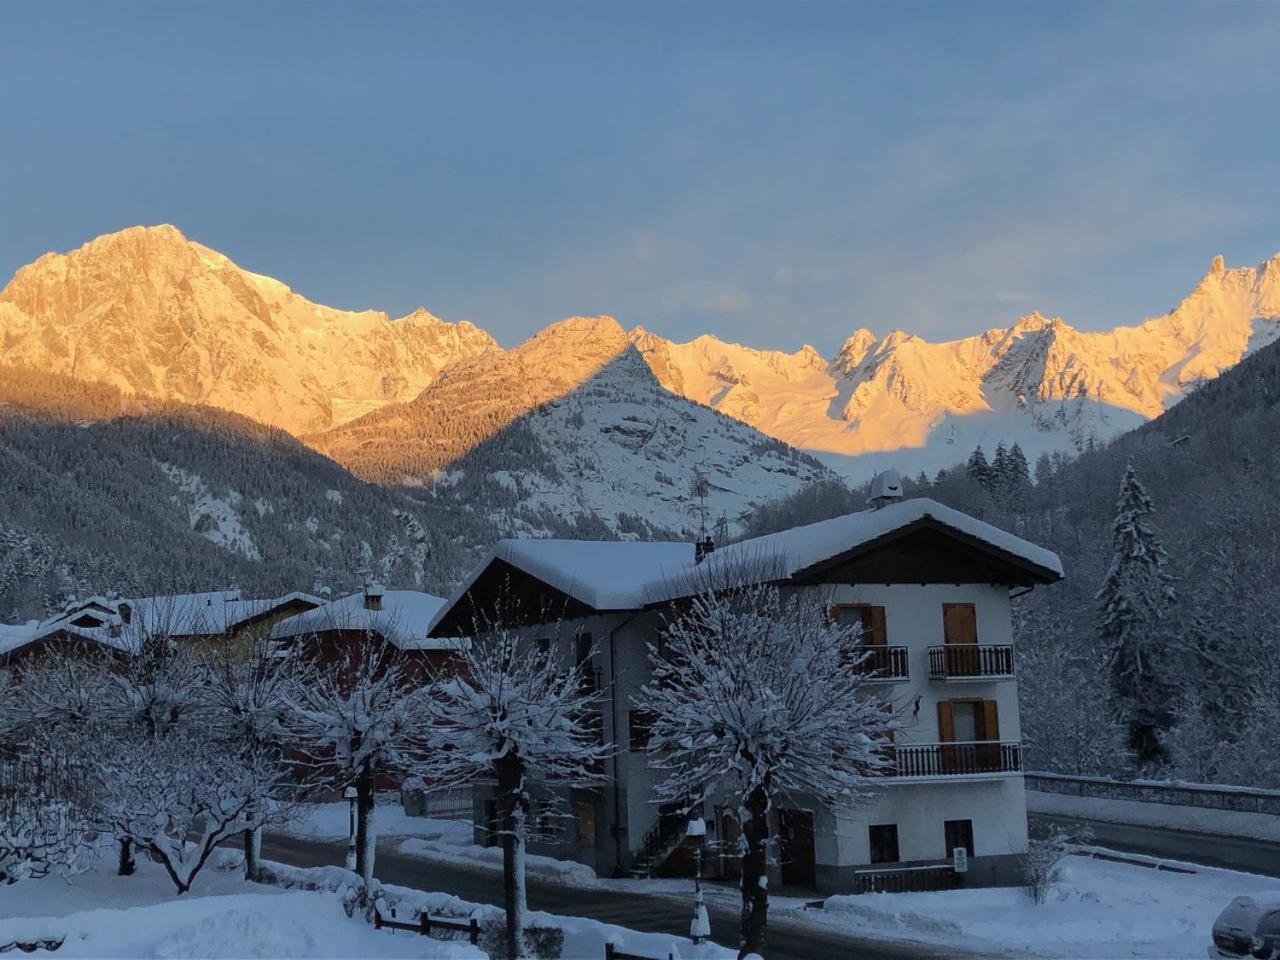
[431,498,1062,628]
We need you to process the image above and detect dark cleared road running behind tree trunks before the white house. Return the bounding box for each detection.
[262,835,962,960]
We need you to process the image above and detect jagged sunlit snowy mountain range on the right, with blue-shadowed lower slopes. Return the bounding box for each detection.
[631,255,1280,476]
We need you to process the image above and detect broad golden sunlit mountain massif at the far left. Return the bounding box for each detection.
[0,225,495,434]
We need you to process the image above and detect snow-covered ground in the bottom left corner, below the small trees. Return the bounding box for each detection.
[0,856,484,960]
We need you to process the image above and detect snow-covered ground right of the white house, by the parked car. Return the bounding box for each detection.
[780,856,1280,957]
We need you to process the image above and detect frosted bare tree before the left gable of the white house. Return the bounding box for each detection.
[420,602,611,957]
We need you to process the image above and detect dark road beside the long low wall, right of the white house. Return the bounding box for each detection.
[1028,813,1280,877]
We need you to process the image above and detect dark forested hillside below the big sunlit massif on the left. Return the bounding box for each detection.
[0,370,495,621]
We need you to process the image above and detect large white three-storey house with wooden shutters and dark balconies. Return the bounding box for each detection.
[430,494,1062,891]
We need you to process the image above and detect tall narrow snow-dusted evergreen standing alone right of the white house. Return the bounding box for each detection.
[1097,461,1175,763]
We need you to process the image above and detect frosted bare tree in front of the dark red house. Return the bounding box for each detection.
[284,635,424,883]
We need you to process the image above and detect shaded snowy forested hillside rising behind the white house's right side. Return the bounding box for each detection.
[749,337,1280,787]
